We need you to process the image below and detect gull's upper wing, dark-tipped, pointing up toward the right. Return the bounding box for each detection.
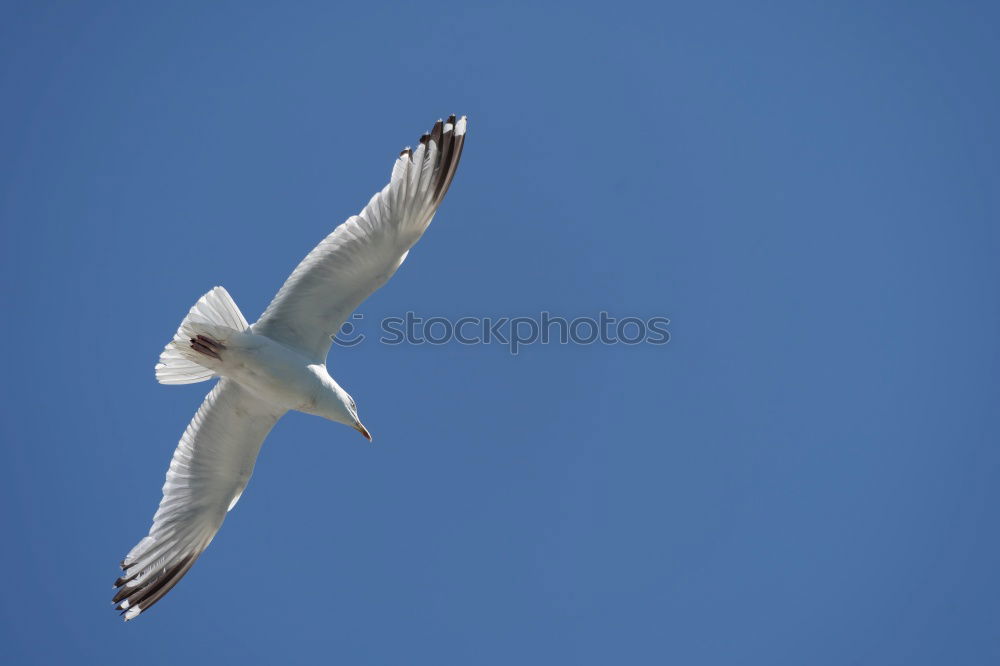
[253,116,466,363]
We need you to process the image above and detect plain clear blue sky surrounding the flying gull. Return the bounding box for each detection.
[0,2,1000,666]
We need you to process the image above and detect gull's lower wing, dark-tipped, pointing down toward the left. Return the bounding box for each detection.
[113,379,284,620]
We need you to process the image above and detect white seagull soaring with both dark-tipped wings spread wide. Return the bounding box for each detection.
[112,116,466,621]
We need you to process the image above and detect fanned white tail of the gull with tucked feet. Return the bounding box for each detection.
[156,287,250,384]
